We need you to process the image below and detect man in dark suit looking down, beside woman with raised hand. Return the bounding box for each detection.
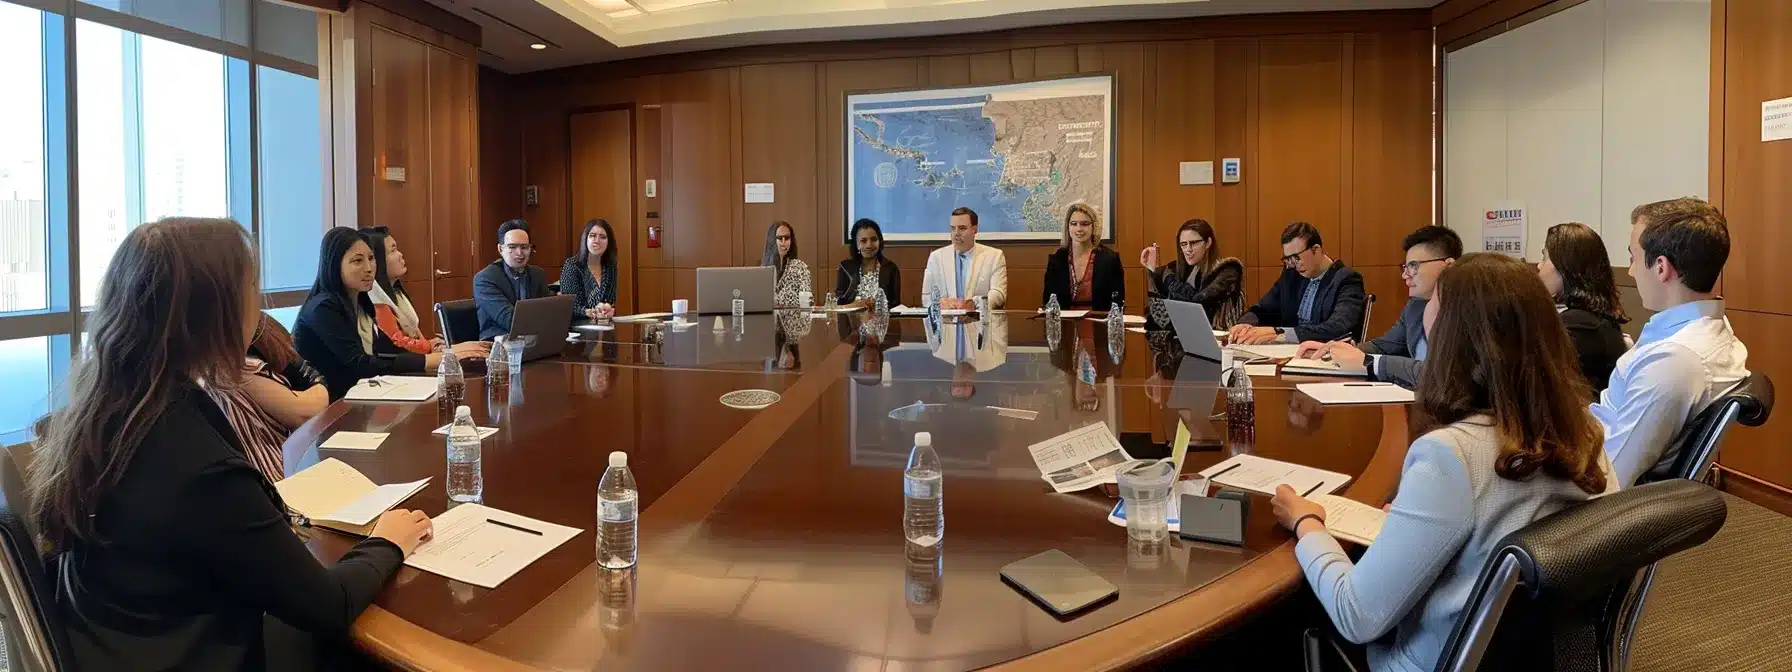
[1231,222,1364,344]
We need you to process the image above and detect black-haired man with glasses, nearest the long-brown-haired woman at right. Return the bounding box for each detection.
[1297,226,1462,389]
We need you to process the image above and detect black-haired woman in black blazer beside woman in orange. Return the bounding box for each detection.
[292,228,489,401]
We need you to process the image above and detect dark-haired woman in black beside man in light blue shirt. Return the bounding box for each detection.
[1538,222,1631,396]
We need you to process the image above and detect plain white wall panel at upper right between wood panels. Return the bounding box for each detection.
[1443,0,1705,265]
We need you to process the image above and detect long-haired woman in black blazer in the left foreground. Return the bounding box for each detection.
[27,219,430,670]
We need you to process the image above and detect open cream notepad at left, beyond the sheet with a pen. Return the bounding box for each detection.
[274,457,430,536]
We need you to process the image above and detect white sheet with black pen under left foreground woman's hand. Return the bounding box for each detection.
[405,504,582,588]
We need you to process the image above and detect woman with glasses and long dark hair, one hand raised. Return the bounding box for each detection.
[1138,219,1244,330]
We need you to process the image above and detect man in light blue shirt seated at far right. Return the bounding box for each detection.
[1591,199,1749,487]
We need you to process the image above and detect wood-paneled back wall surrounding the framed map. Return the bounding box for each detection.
[480,11,1432,336]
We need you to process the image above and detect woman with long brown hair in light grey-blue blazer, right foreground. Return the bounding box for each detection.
[1274,254,1618,670]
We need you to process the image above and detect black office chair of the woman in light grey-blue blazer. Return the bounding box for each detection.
[1306,478,1729,672]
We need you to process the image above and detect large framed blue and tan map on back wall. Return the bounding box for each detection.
[840,75,1115,244]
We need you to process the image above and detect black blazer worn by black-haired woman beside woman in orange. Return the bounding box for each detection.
[292,292,425,401]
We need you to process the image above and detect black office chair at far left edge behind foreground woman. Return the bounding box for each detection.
[0,446,75,672]
